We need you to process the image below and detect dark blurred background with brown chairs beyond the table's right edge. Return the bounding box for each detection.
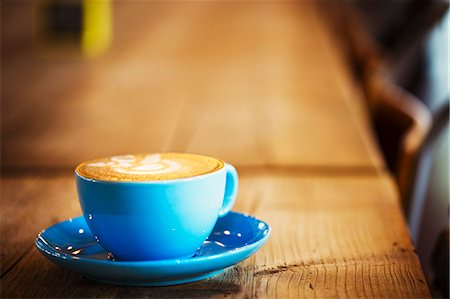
[336,1,450,297]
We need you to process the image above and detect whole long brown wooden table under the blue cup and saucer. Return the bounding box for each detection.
[0,1,429,298]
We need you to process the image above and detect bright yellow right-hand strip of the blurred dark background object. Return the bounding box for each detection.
[81,0,112,57]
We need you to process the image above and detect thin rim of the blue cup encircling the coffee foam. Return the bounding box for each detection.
[74,153,227,185]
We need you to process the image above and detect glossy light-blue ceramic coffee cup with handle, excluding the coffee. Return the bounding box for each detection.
[75,163,238,261]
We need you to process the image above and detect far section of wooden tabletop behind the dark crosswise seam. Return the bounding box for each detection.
[2,1,382,168]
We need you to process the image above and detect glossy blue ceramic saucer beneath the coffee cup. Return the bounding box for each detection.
[35,212,270,286]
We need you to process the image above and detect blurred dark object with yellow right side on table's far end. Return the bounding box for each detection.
[35,0,113,57]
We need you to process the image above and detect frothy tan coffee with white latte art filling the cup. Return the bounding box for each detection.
[76,153,224,182]
